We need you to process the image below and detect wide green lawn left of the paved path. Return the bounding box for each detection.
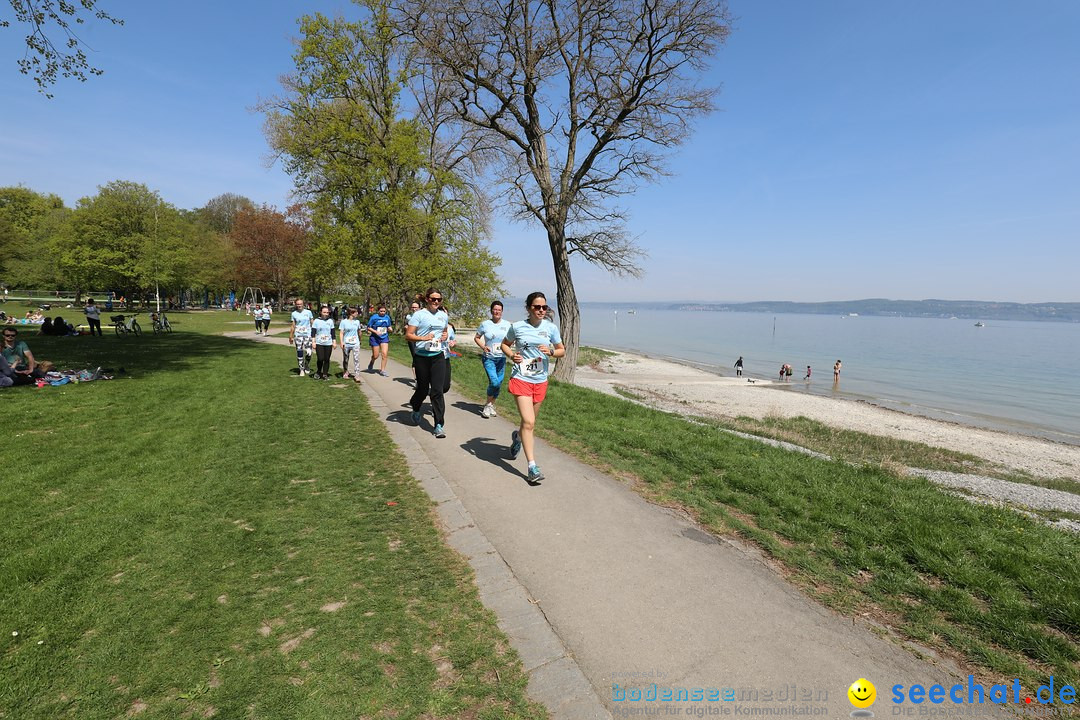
[0,313,546,720]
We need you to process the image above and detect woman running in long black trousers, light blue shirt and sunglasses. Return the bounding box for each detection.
[405,287,449,437]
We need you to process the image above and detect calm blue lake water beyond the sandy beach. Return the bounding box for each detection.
[581,303,1080,445]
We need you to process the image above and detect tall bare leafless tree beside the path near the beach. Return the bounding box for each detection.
[397,0,730,380]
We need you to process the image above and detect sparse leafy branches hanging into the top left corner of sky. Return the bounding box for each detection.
[0,0,124,97]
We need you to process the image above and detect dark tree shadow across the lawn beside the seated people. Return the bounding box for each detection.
[7,331,276,378]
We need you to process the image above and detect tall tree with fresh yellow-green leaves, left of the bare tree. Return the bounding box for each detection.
[265,1,499,321]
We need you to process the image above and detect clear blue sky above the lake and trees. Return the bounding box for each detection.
[0,0,1080,302]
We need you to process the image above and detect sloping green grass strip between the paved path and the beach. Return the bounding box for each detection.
[393,343,1080,689]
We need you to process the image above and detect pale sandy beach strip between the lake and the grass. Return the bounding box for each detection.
[577,353,1080,483]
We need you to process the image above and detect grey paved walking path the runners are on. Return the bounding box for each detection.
[230,334,1002,718]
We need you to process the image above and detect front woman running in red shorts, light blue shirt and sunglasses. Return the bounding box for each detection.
[502,293,566,485]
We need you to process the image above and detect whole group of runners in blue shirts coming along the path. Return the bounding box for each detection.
[288,287,566,485]
